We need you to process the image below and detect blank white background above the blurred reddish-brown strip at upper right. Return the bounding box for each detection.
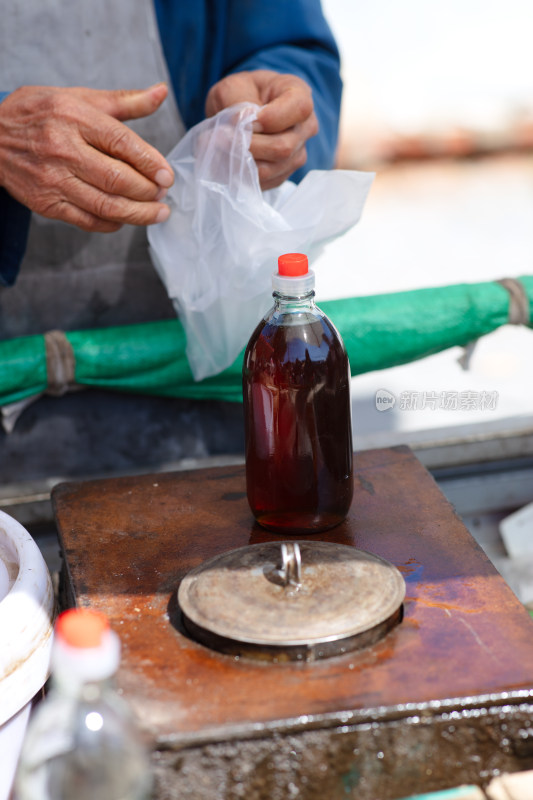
[323,0,533,132]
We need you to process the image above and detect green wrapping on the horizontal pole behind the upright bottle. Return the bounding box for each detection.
[0,276,533,405]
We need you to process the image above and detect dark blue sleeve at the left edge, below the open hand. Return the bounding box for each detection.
[0,92,31,286]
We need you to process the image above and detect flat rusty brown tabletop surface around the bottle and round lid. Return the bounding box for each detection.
[53,448,533,752]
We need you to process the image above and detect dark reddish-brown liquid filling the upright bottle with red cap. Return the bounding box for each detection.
[243,308,353,533]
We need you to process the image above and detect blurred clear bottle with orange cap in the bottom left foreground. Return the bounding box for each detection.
[15,609,152,800]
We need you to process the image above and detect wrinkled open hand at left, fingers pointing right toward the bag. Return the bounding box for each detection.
[0,84,174,232]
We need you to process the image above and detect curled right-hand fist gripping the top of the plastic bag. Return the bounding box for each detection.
[205,70,318,189]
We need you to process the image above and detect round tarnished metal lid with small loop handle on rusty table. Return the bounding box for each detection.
[178,540,405,660]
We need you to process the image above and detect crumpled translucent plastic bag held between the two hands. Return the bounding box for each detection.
[148,103,373,380]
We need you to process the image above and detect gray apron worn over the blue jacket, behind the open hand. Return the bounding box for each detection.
[0,0,184,339]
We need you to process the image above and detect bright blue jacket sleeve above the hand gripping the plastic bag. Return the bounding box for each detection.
[155,0,342,180]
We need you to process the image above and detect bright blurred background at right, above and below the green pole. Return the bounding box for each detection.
[316,0,533,447]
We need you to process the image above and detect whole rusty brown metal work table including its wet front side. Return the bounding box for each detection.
[53,447,533,800]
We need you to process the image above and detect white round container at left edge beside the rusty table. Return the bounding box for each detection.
[0,511,54,800]
